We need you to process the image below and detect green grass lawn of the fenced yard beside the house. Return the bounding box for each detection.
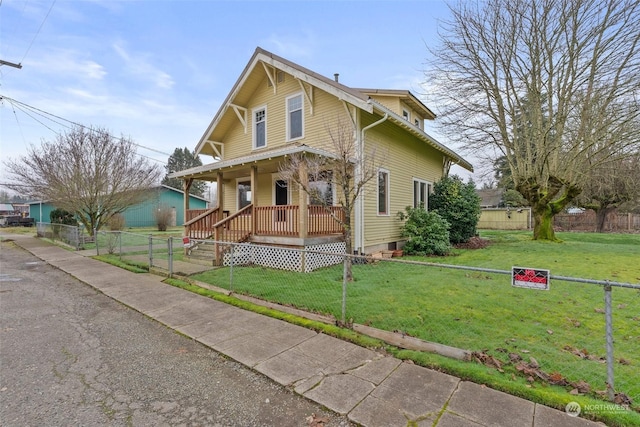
[194,231,640,425]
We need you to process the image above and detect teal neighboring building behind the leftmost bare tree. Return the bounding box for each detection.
[29,185,207,227]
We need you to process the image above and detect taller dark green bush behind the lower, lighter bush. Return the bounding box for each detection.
[429,175,480,245]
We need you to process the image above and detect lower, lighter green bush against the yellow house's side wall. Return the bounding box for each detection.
[398,206,451,255]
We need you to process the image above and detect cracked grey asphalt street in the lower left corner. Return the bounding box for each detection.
[0,242,351,427]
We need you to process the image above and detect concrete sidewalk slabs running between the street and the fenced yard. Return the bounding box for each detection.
[4,235,602,427]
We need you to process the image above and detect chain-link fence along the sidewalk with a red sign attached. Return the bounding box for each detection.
[82,232,640,418]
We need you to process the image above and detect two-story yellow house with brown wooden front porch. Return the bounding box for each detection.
[170,48,473,268]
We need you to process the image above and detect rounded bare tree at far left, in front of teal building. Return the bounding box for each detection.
[5,127,161,230]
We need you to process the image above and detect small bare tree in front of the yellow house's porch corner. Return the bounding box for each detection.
[279,119,380,281]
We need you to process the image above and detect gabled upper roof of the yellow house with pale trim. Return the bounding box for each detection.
[194,47,473,172]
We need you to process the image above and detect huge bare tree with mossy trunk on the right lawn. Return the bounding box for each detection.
[427,0,640,240]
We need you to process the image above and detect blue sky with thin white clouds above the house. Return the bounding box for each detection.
[0,0,471,186]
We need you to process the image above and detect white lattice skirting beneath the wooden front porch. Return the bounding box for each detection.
[223,242,346,273]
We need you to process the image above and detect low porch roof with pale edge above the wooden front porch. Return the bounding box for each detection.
[169,144,342,181]
